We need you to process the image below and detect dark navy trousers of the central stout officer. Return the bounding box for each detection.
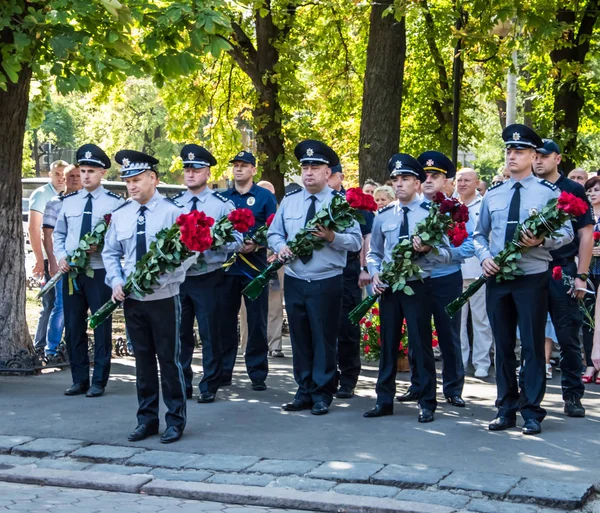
[283,274,344,405]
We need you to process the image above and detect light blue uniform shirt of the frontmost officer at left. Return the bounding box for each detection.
[102,192,189,301]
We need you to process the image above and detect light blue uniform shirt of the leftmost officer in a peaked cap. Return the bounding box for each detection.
[52,186,125,269]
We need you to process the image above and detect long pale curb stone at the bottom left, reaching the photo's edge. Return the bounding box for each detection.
[0,465,152,493]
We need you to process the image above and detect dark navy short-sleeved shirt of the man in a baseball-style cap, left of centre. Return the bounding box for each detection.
[221,184,277,277]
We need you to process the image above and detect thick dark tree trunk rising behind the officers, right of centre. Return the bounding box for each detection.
[358,0,406,184]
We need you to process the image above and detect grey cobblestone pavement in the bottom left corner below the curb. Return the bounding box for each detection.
[0,483,314,513]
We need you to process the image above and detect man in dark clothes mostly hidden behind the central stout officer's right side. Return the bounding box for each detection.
[328,164,375,399]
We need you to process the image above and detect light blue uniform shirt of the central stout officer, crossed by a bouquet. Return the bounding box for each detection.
[268,185,362,281]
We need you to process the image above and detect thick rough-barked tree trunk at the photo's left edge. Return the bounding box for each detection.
[0,68,33,365]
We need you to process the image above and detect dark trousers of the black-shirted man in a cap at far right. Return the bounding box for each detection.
[548,262,585,399]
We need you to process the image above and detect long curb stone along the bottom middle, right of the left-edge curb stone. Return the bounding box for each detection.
[142,479,458,513]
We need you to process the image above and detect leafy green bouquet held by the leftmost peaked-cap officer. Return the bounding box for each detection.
[36,214,111,299]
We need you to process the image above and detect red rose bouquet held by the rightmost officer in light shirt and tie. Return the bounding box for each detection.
[446,191,589,317]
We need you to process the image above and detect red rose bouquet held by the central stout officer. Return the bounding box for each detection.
[242,187,377,300]
